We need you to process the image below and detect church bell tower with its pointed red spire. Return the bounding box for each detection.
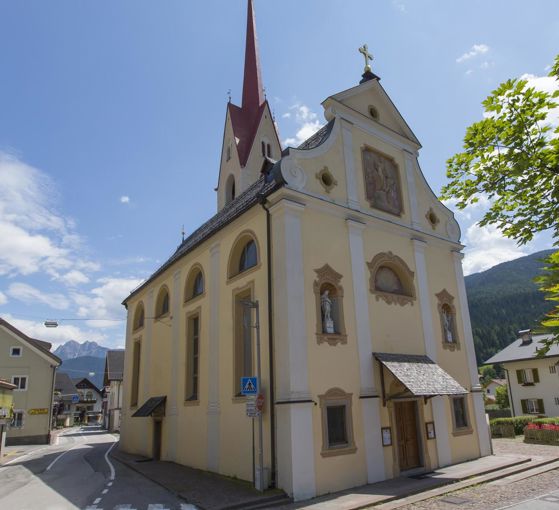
[217,0,281,210]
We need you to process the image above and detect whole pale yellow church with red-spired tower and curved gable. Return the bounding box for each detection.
[121,0,490,500]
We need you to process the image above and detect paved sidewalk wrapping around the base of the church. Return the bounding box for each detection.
[112,451,557,510]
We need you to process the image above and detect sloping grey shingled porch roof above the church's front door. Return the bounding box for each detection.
[373,352,468,397]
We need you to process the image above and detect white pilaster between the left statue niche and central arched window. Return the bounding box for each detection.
[346,219,386,483]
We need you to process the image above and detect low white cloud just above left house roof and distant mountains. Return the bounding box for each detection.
[2,315,109,351]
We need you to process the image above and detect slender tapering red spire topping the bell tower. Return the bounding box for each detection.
[242,0,264,112]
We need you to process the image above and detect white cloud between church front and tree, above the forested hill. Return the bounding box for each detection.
[464,224,529,275]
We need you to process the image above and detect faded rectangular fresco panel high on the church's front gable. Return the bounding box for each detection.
[363,148,402,216]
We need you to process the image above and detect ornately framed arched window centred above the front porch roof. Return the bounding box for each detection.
[367,251,415,306]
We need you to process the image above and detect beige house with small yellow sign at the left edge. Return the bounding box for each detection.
[0,318,61,445]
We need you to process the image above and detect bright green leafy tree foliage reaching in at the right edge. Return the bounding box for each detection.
[442,55,559,354]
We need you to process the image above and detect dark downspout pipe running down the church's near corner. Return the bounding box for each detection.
[260,197,276,488]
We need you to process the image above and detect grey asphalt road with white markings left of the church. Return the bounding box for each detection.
[0,427,194,510]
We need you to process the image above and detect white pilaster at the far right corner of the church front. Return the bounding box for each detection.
[452,251,491,457]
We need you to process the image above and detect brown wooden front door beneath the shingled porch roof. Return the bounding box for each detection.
[394,400,421,471]
